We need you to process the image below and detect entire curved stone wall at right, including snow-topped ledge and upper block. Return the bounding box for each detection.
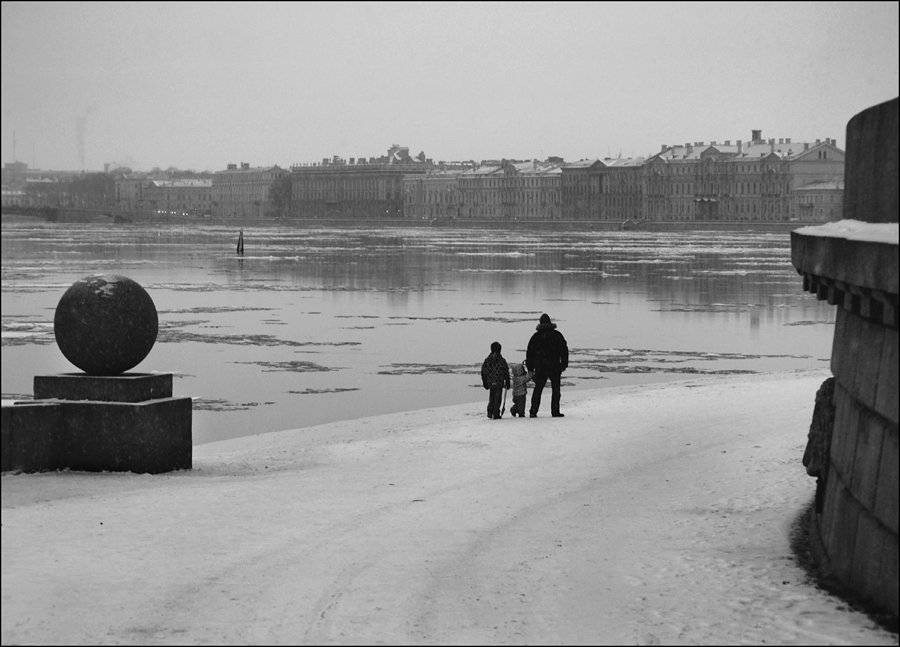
[791,99,900,616]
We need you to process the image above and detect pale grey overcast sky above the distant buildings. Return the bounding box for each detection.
[0,0,900,171]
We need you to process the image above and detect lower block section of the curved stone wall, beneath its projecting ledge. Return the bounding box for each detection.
[818,311,900,614]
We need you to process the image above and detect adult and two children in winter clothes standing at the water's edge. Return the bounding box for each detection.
[481,313,569,420]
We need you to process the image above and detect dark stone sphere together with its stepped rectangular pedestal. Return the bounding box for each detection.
[0,274,193,474]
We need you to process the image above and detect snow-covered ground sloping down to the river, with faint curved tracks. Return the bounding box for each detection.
[2,372,898,645]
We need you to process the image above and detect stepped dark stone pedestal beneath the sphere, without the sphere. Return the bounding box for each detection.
[0,373,192,474]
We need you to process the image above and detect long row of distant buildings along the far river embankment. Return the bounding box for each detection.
[3,130,844,225]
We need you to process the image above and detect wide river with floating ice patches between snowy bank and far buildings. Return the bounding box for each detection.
[2,223,834,443]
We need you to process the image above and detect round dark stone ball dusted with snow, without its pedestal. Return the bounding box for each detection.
[53,274,159,375]
